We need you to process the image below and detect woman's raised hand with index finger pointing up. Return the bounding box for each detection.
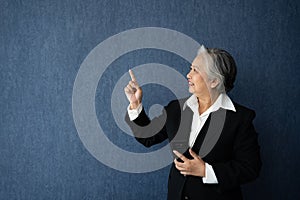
[124,70,143,109]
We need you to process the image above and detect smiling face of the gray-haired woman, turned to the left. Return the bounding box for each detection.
[187,55,210,97]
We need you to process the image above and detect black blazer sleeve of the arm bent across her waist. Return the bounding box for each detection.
[212,110,262,191]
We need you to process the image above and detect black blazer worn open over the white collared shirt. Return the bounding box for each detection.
[125,98,261,200]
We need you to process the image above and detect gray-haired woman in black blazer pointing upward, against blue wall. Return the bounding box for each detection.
[124,46,261,200]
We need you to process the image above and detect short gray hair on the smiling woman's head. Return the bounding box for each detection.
[197,45,237,93]
